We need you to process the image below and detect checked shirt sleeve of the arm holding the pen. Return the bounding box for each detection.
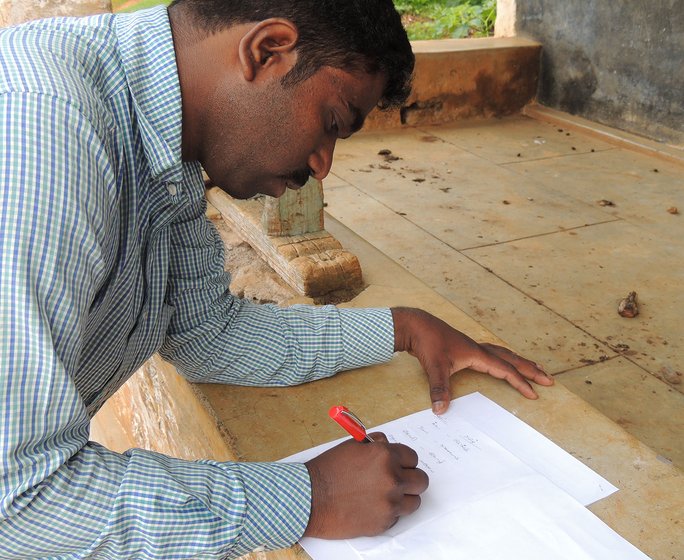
[0,94,310,559]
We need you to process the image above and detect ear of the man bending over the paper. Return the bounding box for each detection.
[238,18,299,82]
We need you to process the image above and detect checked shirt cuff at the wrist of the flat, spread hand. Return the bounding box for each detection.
[339,308,394,370]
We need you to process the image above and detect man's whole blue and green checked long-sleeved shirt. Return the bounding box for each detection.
[0,8,393,560]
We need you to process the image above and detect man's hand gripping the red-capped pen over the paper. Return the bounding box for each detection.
[304,433,428,539]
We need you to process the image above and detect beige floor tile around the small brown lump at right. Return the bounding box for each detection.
[466,222,684,389]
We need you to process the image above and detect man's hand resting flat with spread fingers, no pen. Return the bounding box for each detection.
[392,307,553,414]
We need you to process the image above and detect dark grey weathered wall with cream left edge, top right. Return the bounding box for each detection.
[497,0,684,146]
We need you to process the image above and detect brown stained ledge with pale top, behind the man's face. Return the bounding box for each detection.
[364,37,541,130]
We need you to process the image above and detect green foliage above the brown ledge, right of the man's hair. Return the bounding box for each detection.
[394,0,496,40]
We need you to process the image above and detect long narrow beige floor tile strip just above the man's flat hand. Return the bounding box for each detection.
[326,186,615,373]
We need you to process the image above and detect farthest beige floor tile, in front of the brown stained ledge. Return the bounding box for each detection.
[423,116,613,163]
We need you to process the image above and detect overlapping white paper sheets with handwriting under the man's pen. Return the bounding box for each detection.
[284,393,647,560]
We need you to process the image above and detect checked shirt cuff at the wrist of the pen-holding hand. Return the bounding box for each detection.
[231,463,311,552]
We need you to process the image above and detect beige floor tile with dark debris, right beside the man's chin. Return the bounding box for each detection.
[326,130,615,249]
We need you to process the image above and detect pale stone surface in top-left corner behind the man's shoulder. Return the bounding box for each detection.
[0,0,112,27]
